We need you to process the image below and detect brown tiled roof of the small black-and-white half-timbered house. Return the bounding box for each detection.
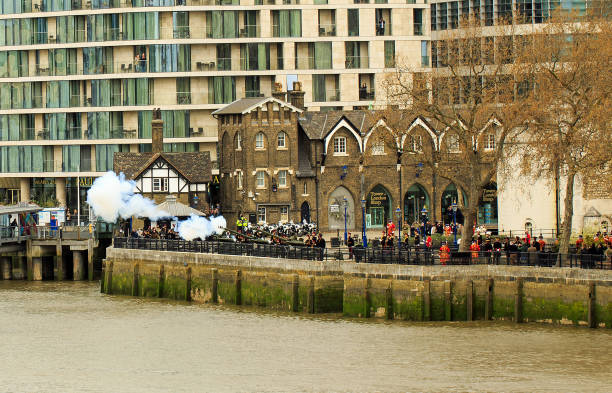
[113,151,212,183]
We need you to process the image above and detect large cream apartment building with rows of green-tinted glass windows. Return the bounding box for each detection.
[0,0,430,209]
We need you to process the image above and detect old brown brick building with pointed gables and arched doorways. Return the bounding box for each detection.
[214,84,497,231]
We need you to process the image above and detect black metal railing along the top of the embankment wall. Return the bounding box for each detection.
[113,237,612,269]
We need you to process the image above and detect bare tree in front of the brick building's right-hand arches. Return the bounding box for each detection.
[386,19,531,250]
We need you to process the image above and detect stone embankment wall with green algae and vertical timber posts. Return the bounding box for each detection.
[101,248,612,327]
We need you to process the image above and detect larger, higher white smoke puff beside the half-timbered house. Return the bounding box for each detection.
[87,171,170,223]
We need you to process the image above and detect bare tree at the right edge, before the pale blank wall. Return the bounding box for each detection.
[521,10,612,253]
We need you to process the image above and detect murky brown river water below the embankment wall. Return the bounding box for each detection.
[0,281,612,393]
